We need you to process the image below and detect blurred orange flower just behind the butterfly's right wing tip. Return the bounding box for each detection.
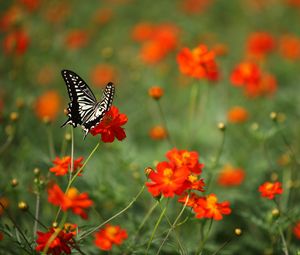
[90,64,117,87]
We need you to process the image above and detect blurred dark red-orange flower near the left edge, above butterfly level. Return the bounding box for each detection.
[3,29,29,56]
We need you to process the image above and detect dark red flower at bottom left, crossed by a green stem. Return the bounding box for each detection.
[35,228,74,255]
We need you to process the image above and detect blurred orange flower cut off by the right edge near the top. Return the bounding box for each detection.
[279,35,300,60]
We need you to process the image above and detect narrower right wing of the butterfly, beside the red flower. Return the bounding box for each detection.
[82,82,115,136]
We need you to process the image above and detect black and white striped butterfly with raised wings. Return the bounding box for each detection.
[61,70,115,138]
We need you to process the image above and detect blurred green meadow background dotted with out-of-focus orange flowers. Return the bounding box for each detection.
[0,0,300,254]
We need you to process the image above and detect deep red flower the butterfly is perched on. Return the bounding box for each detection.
[90,106,128,143]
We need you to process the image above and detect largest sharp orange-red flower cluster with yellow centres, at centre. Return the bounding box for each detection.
[146,148,204,197]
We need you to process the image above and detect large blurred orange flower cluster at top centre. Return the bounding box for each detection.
[132,23,179,64]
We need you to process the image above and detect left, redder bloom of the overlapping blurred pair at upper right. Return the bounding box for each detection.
[230,62,261,86]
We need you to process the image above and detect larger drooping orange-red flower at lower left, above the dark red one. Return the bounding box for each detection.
[48,184,93,219]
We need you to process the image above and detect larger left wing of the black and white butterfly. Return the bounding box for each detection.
[61,70,97,127]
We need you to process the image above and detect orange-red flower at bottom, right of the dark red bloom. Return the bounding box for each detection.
[95,224,128,251]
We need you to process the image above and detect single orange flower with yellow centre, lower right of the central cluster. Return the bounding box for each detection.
[194,194,231,220]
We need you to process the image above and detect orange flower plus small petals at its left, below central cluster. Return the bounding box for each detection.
[178,193,231,220]
